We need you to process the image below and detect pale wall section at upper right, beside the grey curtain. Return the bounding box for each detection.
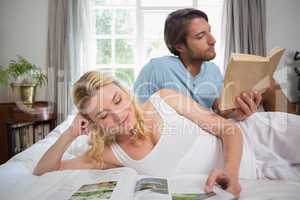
[266,0,300,51]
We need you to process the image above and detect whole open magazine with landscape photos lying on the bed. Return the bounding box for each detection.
[44,167,235,200]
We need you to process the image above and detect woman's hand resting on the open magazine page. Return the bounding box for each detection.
[204,169,241,197]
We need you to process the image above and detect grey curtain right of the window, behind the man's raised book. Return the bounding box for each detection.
[221,0,266,71]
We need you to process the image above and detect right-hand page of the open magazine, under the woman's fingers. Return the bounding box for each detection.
[134,175,236,200]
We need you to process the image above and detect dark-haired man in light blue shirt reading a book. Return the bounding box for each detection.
[134,8,276,120]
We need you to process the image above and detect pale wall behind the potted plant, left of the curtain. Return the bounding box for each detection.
[0,0,48,102]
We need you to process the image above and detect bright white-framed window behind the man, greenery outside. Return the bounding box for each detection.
[91,0,223,85]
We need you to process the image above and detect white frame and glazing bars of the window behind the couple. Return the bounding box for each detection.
[92,0,223,79]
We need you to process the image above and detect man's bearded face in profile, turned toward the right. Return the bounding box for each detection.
[180,18,216,61]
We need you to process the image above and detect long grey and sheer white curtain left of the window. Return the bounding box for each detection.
[47,0,96,123]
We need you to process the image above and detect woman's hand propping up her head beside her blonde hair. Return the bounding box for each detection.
[67,114,90,138]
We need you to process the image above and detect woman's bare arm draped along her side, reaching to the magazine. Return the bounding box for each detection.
[159,89,243,195]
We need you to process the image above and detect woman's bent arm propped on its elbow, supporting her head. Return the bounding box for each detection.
[33,115,92,175]
